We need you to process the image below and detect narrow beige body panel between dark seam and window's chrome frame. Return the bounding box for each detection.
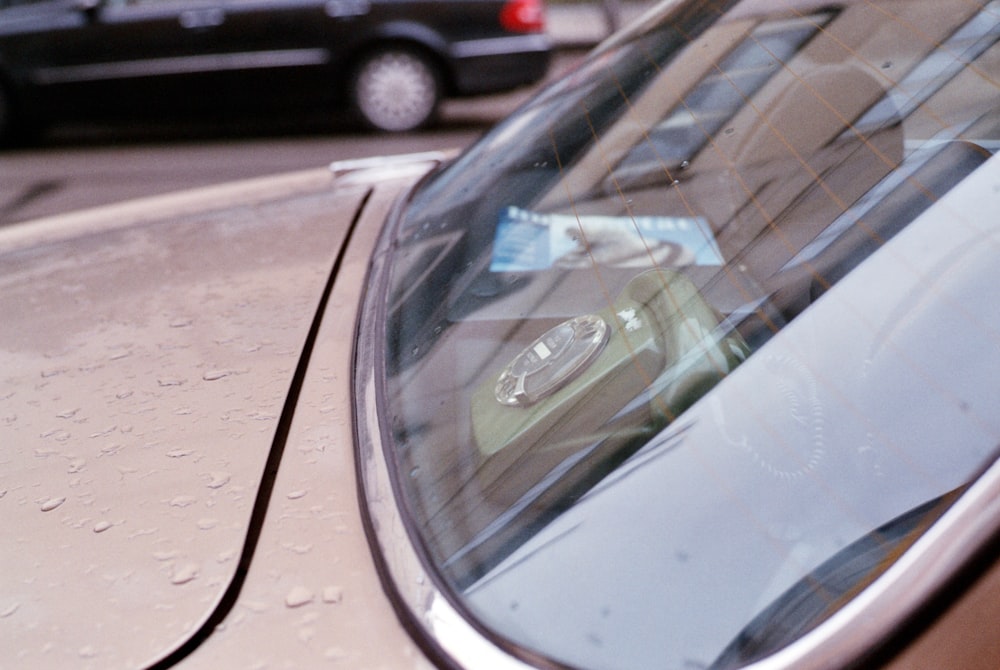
[178,163,442,670]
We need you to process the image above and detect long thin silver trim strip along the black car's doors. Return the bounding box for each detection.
[32,49,330,85]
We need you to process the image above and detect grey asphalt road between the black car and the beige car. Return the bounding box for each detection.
[0,52,580,226]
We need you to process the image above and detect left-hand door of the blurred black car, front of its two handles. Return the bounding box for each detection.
[0,0,237,117]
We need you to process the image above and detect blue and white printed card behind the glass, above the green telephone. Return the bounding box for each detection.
[490,207,723,272]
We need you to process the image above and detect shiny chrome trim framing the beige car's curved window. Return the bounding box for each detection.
[354,165,1000,670]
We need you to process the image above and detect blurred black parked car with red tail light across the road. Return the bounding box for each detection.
[0,0,549,139]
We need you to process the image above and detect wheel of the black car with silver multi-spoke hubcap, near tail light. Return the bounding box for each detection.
[351,47,443,132]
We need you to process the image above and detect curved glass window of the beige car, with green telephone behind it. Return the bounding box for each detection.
[368,0,1000,668]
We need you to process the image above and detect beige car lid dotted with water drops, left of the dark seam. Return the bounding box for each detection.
[0,160,436,667]
